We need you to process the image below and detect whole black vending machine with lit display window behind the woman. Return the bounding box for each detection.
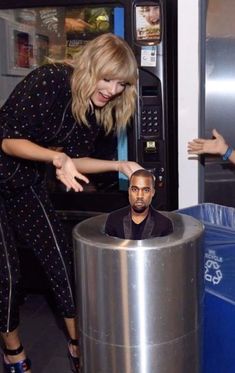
[0,0,178,220]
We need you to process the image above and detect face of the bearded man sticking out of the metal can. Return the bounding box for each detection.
[128,176,155,213]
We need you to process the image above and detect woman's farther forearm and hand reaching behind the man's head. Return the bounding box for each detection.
[73,157,143,178]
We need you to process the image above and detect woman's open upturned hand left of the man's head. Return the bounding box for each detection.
[53,153,89,192]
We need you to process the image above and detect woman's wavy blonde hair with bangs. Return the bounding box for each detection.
[71,33,137,133]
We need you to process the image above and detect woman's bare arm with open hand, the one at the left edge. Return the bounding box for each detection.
[2,139,89,192]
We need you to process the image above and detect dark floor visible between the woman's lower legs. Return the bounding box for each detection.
[0,294,71,373]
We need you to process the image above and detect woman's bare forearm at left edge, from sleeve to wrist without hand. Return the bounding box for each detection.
[2,139,59,162]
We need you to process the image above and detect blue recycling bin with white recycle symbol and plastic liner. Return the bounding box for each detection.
[178,203,235,373]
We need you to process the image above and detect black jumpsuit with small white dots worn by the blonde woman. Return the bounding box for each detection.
[0,64,99,332]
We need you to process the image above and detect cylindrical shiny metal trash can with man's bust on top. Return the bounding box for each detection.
[73,212,203,373]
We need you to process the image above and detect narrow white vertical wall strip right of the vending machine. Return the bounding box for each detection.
[178,0,200,208]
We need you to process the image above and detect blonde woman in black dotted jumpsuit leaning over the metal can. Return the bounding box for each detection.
[0,34,141,372]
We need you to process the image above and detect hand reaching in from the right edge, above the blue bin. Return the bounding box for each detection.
[188,129,228,155]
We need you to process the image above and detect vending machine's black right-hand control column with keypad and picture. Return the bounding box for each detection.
[126,0,177,210]
